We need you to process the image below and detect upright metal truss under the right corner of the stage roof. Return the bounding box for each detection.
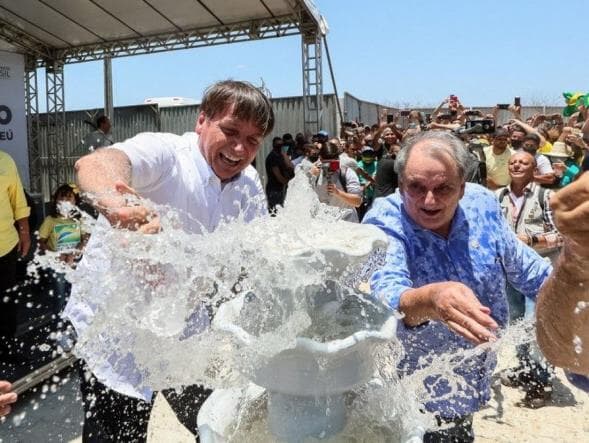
[302,29,323,134]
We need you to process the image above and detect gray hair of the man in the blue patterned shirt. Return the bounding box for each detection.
[395,131,472,181]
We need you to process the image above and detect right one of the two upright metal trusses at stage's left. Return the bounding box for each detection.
[45,61,66,192]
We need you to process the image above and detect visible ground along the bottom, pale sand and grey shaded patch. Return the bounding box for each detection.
[0,357,589,443]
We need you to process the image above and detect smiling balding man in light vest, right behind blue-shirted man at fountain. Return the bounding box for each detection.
[495,153,562,408]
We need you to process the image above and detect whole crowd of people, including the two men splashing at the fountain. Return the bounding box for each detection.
[0,86,589,442]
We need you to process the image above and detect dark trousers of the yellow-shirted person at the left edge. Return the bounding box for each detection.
[0,247,18,360]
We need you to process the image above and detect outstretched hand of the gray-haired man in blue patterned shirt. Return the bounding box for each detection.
[430,282,498,345]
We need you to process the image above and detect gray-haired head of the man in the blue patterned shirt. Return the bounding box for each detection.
[395,131,471,237]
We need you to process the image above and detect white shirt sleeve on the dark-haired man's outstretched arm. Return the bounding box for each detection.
[108,132,176,193]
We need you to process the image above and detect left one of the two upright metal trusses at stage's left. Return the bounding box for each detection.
[25,55,43,192]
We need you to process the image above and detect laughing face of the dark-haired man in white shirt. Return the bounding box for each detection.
[195,107,264,180]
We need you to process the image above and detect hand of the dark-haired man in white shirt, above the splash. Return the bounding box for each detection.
[104,181,161,234]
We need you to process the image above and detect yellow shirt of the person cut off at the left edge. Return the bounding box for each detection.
[0,151,31,257]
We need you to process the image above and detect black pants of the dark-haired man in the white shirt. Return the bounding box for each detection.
[80,368,212,443]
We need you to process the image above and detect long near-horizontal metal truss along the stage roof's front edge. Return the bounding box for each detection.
[50,15,300,64]
